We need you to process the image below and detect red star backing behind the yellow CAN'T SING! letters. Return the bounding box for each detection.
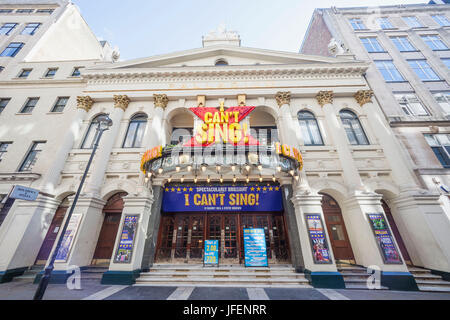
[184,105,259,147]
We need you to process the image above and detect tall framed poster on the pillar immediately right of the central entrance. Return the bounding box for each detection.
[305,214,332,264]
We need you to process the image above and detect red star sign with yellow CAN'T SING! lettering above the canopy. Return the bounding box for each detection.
[184,102,259,147]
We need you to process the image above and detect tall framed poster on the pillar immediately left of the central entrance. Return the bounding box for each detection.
[114,214,139,263]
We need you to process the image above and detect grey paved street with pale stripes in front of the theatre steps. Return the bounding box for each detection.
[0,280,450,301]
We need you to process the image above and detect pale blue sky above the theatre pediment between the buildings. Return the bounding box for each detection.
[72,0,428,60]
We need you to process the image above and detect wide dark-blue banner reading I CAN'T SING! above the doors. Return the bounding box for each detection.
[163,186,283,212]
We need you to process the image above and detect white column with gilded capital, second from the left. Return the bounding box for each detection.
[86,95,130,197]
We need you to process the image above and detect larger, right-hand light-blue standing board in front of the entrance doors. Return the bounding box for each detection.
[244,228,269,267]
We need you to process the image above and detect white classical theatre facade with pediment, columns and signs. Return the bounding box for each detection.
[0,30,450,290]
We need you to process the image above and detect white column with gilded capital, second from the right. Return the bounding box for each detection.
[316,91,364,192]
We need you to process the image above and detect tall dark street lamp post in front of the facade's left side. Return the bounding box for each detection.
[33,115,112,300]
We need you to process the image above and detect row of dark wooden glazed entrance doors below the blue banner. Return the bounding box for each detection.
[156,213,290,264]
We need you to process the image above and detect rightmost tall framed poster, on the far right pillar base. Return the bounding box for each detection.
[367,213,403,264]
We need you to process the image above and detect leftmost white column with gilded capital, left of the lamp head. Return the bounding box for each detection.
[40,96,94,194]
